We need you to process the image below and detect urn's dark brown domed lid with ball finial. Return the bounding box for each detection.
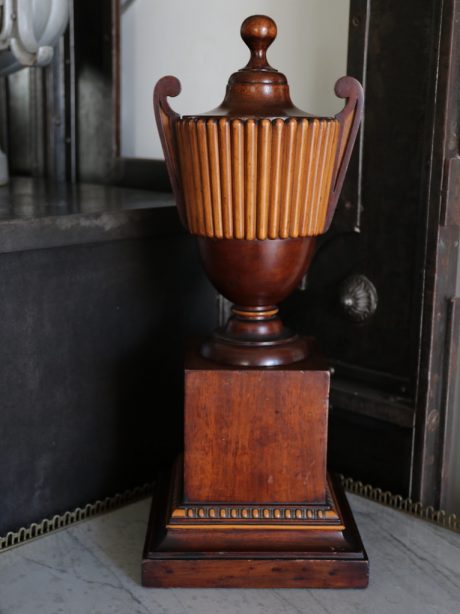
[185,15,318,118]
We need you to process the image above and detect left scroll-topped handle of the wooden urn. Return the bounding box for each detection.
[153,76,187,227]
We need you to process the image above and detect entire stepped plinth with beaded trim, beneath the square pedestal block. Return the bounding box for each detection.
[142,462,369,588]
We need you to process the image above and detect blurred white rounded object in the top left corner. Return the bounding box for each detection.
[0,0,69,75]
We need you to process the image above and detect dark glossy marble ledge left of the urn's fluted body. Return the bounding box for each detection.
[0,177,179,253]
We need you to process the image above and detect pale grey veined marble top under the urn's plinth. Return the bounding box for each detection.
[0,496,460,614]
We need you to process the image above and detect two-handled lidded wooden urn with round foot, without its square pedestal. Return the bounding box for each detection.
[154,16,363,366]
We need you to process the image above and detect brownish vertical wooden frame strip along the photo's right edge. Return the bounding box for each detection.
[413,0,460,512]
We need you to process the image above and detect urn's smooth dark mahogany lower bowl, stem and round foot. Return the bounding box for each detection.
[198,237,315,367]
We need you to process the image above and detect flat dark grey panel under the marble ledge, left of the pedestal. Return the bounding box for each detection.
[0,229,216,534]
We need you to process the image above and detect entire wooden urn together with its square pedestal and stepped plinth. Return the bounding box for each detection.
[142,15,368,588]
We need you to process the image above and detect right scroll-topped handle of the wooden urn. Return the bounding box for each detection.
[325,77,364,231]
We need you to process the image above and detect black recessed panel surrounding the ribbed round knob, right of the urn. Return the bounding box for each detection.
[286,0,432,394]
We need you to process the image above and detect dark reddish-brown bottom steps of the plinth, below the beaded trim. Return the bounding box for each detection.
[142,474,369,588]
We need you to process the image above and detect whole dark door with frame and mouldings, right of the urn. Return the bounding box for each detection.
[284,0,460,506]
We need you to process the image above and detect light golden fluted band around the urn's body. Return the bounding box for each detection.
[176,117,343,240]
